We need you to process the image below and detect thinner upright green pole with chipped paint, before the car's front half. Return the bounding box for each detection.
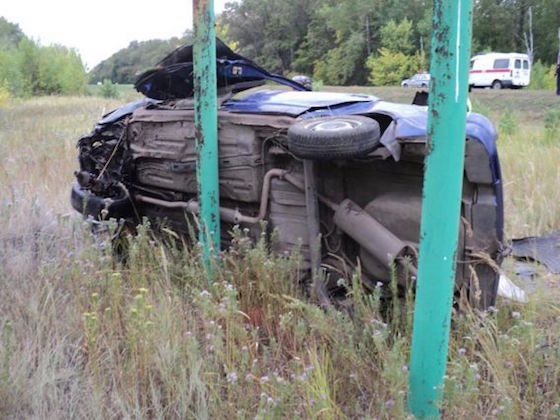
[193,0,220,267]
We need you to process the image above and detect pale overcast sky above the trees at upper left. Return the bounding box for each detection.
[0,0,232,69]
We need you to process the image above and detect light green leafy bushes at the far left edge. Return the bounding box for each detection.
[0,17,88,97]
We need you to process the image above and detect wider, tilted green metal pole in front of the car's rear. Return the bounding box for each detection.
[408,0,472,418]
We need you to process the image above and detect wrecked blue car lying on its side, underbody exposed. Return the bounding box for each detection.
[71,40,503,308]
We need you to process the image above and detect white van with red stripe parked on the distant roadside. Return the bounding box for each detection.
[469,53,531,89]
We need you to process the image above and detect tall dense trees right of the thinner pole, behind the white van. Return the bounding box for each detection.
[218,0,560,85]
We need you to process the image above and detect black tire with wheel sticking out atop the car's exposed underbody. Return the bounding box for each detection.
[288,115,381,160]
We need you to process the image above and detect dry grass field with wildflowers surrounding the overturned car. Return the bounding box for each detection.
[0,88,560,419]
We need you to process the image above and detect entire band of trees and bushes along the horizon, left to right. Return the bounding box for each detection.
[0,0,560,96]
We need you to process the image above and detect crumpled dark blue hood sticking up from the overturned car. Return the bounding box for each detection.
[134,38,308,100]
